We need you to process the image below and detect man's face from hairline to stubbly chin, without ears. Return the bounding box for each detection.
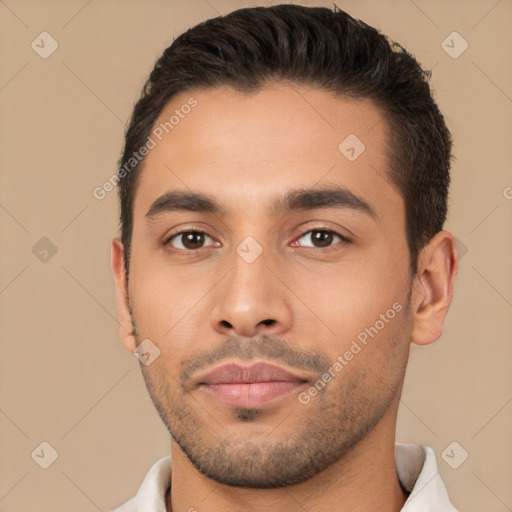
[120,85,411,488]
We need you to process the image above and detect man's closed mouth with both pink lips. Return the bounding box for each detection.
[198,362,308,408]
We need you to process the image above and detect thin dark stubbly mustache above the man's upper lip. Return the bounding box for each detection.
[179,335,332,390]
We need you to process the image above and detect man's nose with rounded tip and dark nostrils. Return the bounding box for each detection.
[211,245,292,337]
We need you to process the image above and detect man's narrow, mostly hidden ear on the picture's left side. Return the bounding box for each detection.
[112,238,137,352]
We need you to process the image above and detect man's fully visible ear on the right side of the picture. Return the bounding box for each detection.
[411,231,459,345]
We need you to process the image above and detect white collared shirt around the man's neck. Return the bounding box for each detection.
[112,443,457,512]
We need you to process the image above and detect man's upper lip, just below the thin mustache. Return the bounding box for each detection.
[197,362,307,384]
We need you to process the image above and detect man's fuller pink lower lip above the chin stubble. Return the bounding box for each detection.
[202,381,303,408]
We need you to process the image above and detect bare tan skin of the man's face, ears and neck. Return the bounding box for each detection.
[112,84,457,512]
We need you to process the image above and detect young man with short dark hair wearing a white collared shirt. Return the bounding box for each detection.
[112,5,457,512]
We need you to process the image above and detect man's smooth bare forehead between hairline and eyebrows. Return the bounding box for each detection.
[135,84,402,220]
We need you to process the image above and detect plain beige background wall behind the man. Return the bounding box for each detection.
[0,0,512,512]
